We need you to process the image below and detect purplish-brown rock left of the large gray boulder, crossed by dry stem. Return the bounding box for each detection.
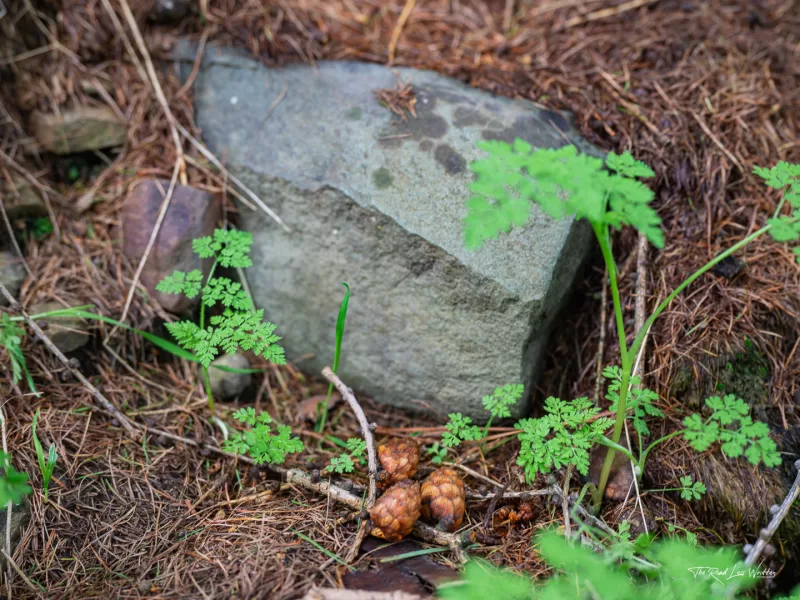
[122,179,220,313]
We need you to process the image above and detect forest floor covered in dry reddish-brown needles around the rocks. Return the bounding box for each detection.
[0,0,800,599]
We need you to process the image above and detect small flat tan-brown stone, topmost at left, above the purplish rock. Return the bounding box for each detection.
[30,106,128,154]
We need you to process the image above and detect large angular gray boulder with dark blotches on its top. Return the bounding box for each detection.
[184,49,596,416]
